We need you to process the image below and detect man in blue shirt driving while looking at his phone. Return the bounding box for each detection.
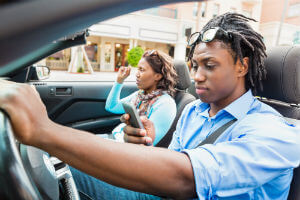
[0,13,300,199]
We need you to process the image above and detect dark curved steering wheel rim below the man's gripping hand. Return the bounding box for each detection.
[0,110,42,200]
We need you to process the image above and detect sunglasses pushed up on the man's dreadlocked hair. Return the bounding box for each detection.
[188,27,231,46]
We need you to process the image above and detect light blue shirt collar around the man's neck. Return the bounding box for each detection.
[194,90,254,120]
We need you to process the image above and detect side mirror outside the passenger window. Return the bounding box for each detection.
[27,65,50,81]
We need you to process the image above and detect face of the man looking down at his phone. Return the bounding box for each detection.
[192,40,247,106]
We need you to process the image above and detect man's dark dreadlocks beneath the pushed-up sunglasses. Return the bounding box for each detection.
[189,13,266,95]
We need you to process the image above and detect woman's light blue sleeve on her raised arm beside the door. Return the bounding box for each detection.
[105,82,137,114]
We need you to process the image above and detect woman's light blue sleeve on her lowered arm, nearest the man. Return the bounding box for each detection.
[149,95,176,146]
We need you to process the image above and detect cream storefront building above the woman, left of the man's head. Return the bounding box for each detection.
[88,3,197,71]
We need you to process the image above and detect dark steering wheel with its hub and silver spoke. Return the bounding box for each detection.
[0,110,80,200]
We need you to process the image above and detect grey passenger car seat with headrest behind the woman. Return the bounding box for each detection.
[156,60,196,148]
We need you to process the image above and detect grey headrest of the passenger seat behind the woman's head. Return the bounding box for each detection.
[174,60,192,90]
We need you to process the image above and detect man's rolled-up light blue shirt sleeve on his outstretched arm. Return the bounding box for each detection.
[183,113,300,199]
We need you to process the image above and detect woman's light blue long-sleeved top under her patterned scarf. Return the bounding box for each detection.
[105,82,177,146]
